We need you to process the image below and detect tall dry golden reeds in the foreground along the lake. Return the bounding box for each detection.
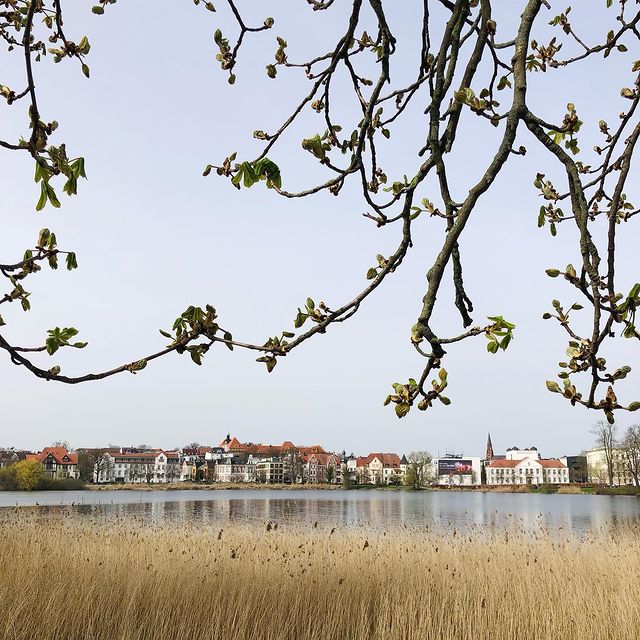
[0,509,640,640]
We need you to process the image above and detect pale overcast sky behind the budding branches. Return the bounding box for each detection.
[0,0,640,456]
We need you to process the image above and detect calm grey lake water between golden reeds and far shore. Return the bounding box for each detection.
[0,489,640,534]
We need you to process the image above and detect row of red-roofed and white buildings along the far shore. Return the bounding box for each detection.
[0,434,634,486]
